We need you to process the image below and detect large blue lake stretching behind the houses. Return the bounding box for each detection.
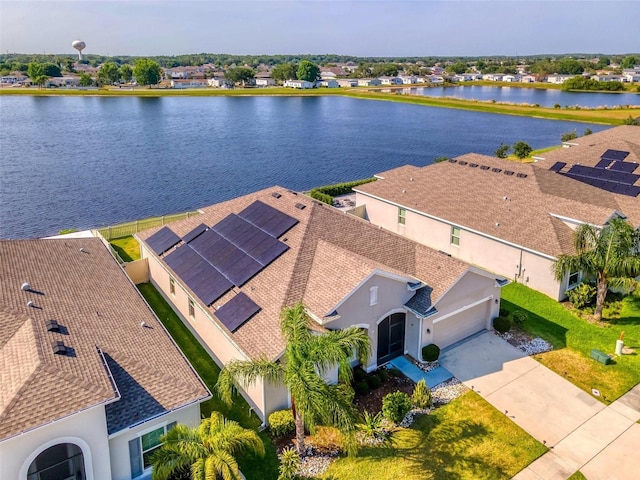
[0,96,608,238]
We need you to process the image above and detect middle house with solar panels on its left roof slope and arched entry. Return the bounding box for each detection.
[137,187,503,421]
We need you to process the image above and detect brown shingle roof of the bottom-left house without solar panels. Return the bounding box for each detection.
[0,239,209,438]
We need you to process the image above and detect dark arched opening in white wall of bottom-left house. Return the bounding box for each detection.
[27,443,86,480]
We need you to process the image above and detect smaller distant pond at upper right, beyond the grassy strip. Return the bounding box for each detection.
[395,85,640,108]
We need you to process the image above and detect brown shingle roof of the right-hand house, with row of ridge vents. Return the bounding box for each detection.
[356,147,640,257]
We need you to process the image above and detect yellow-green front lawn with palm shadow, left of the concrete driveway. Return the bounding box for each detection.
[324,392,547,480]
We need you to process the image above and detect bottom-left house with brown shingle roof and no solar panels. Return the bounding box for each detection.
[0,238,211,480]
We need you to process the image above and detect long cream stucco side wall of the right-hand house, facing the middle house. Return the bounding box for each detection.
[356,193,566,300]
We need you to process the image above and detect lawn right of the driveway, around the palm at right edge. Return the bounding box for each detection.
[502,283,640,404]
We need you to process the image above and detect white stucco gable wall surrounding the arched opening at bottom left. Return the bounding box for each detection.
[0,406,111,480]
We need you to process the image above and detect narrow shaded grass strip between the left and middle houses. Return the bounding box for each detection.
[138,283,279,480]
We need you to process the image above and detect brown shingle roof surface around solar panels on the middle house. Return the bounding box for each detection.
[138,187,468,358]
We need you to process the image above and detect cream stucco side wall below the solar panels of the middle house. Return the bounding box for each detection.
[141,244,268,421]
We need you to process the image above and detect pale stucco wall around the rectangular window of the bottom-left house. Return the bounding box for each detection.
[109,403,200,480]
